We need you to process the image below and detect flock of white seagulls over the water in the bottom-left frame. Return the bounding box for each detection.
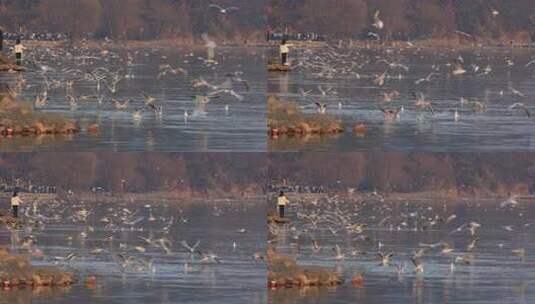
[4,200,264,274]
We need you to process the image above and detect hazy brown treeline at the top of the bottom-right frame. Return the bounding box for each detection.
[268,152,535,195]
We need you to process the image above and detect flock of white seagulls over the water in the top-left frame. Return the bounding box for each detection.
[4,24,250,126]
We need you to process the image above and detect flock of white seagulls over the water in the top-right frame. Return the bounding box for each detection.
[284,40,535,122]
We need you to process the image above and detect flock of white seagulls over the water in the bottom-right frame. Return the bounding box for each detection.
[269,191,535,278]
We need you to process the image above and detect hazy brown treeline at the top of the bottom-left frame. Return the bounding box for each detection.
[0,152,267,195]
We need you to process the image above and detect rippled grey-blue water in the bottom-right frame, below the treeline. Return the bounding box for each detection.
[268,196,535,303]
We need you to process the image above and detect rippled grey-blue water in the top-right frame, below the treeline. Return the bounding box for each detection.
[268,49,535,152]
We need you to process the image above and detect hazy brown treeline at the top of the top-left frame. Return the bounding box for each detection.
[0,0,266,40]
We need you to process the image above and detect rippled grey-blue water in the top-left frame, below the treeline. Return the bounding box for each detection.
[0,47,267,151]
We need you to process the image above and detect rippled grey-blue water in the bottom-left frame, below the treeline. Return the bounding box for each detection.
[0,201,266,303]
